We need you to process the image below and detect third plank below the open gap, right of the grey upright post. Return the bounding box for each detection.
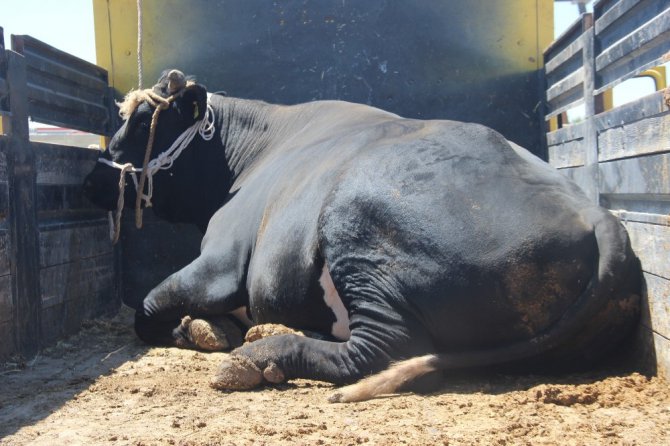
[599,153,670,195]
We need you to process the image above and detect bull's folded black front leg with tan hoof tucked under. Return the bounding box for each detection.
[135,256,248,351]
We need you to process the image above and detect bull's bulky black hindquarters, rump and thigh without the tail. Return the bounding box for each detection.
[322,122,636,358]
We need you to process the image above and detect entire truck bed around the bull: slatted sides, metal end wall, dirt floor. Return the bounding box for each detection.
[0,0,670,445]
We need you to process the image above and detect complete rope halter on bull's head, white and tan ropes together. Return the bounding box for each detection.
[98,86,215,243]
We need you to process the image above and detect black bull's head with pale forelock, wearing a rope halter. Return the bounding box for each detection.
[84,70,207,239]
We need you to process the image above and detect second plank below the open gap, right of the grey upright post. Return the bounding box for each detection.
[598,113,670,161]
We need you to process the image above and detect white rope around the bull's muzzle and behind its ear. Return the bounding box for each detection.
[98,101,216,243]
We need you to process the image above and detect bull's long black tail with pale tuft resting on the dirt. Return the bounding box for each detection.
[329,209,641,403]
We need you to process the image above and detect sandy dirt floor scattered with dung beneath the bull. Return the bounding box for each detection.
[0,314,670,446]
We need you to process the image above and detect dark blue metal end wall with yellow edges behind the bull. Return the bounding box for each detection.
[93,0,553,306]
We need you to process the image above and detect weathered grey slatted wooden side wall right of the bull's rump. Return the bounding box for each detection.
[544,0,670,376]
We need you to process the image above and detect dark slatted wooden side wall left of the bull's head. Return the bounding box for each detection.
[0,28,120,359]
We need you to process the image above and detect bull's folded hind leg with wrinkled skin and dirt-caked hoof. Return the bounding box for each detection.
[212,309,439,394]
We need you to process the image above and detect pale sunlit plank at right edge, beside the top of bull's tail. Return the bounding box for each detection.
[622,221,670,280]
